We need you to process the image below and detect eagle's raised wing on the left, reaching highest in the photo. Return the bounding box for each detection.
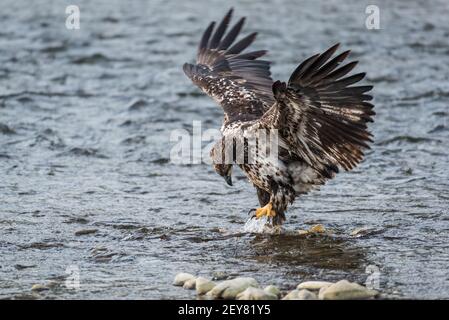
[183,9,275,121]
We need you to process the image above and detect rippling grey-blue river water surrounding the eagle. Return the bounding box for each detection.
[0,0,449,299]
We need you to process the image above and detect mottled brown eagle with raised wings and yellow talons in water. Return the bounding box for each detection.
[183,8,375,225]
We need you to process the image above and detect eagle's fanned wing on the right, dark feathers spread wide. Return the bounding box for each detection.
[260,44,375,176]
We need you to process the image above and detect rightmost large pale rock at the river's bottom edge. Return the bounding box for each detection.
[319,280,378,300]
